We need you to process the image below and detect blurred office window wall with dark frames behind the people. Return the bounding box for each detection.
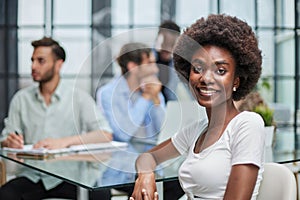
[0,0,300,145]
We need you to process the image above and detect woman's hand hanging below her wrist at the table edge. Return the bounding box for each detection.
[130,172,158,200]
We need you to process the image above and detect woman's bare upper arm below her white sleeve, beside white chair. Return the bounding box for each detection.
[224,164,259,200]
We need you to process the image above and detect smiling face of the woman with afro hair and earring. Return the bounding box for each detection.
[189,45,239,108]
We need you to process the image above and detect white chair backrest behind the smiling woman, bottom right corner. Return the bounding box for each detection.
[257,163,297,200]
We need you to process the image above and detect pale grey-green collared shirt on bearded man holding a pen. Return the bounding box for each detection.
[0,81,112,189]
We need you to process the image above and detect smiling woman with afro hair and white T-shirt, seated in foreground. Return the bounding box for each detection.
[131,15,264,200]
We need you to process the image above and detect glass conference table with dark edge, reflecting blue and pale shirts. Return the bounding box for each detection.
[0,138,300,200]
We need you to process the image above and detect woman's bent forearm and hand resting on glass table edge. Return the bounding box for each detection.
[131,139,180,200]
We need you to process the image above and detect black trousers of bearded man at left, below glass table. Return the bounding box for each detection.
[0,177,110,200]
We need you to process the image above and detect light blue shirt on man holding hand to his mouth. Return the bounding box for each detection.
[96,76,165,142]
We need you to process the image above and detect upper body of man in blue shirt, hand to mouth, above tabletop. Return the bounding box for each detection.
[96,43,165,143]
